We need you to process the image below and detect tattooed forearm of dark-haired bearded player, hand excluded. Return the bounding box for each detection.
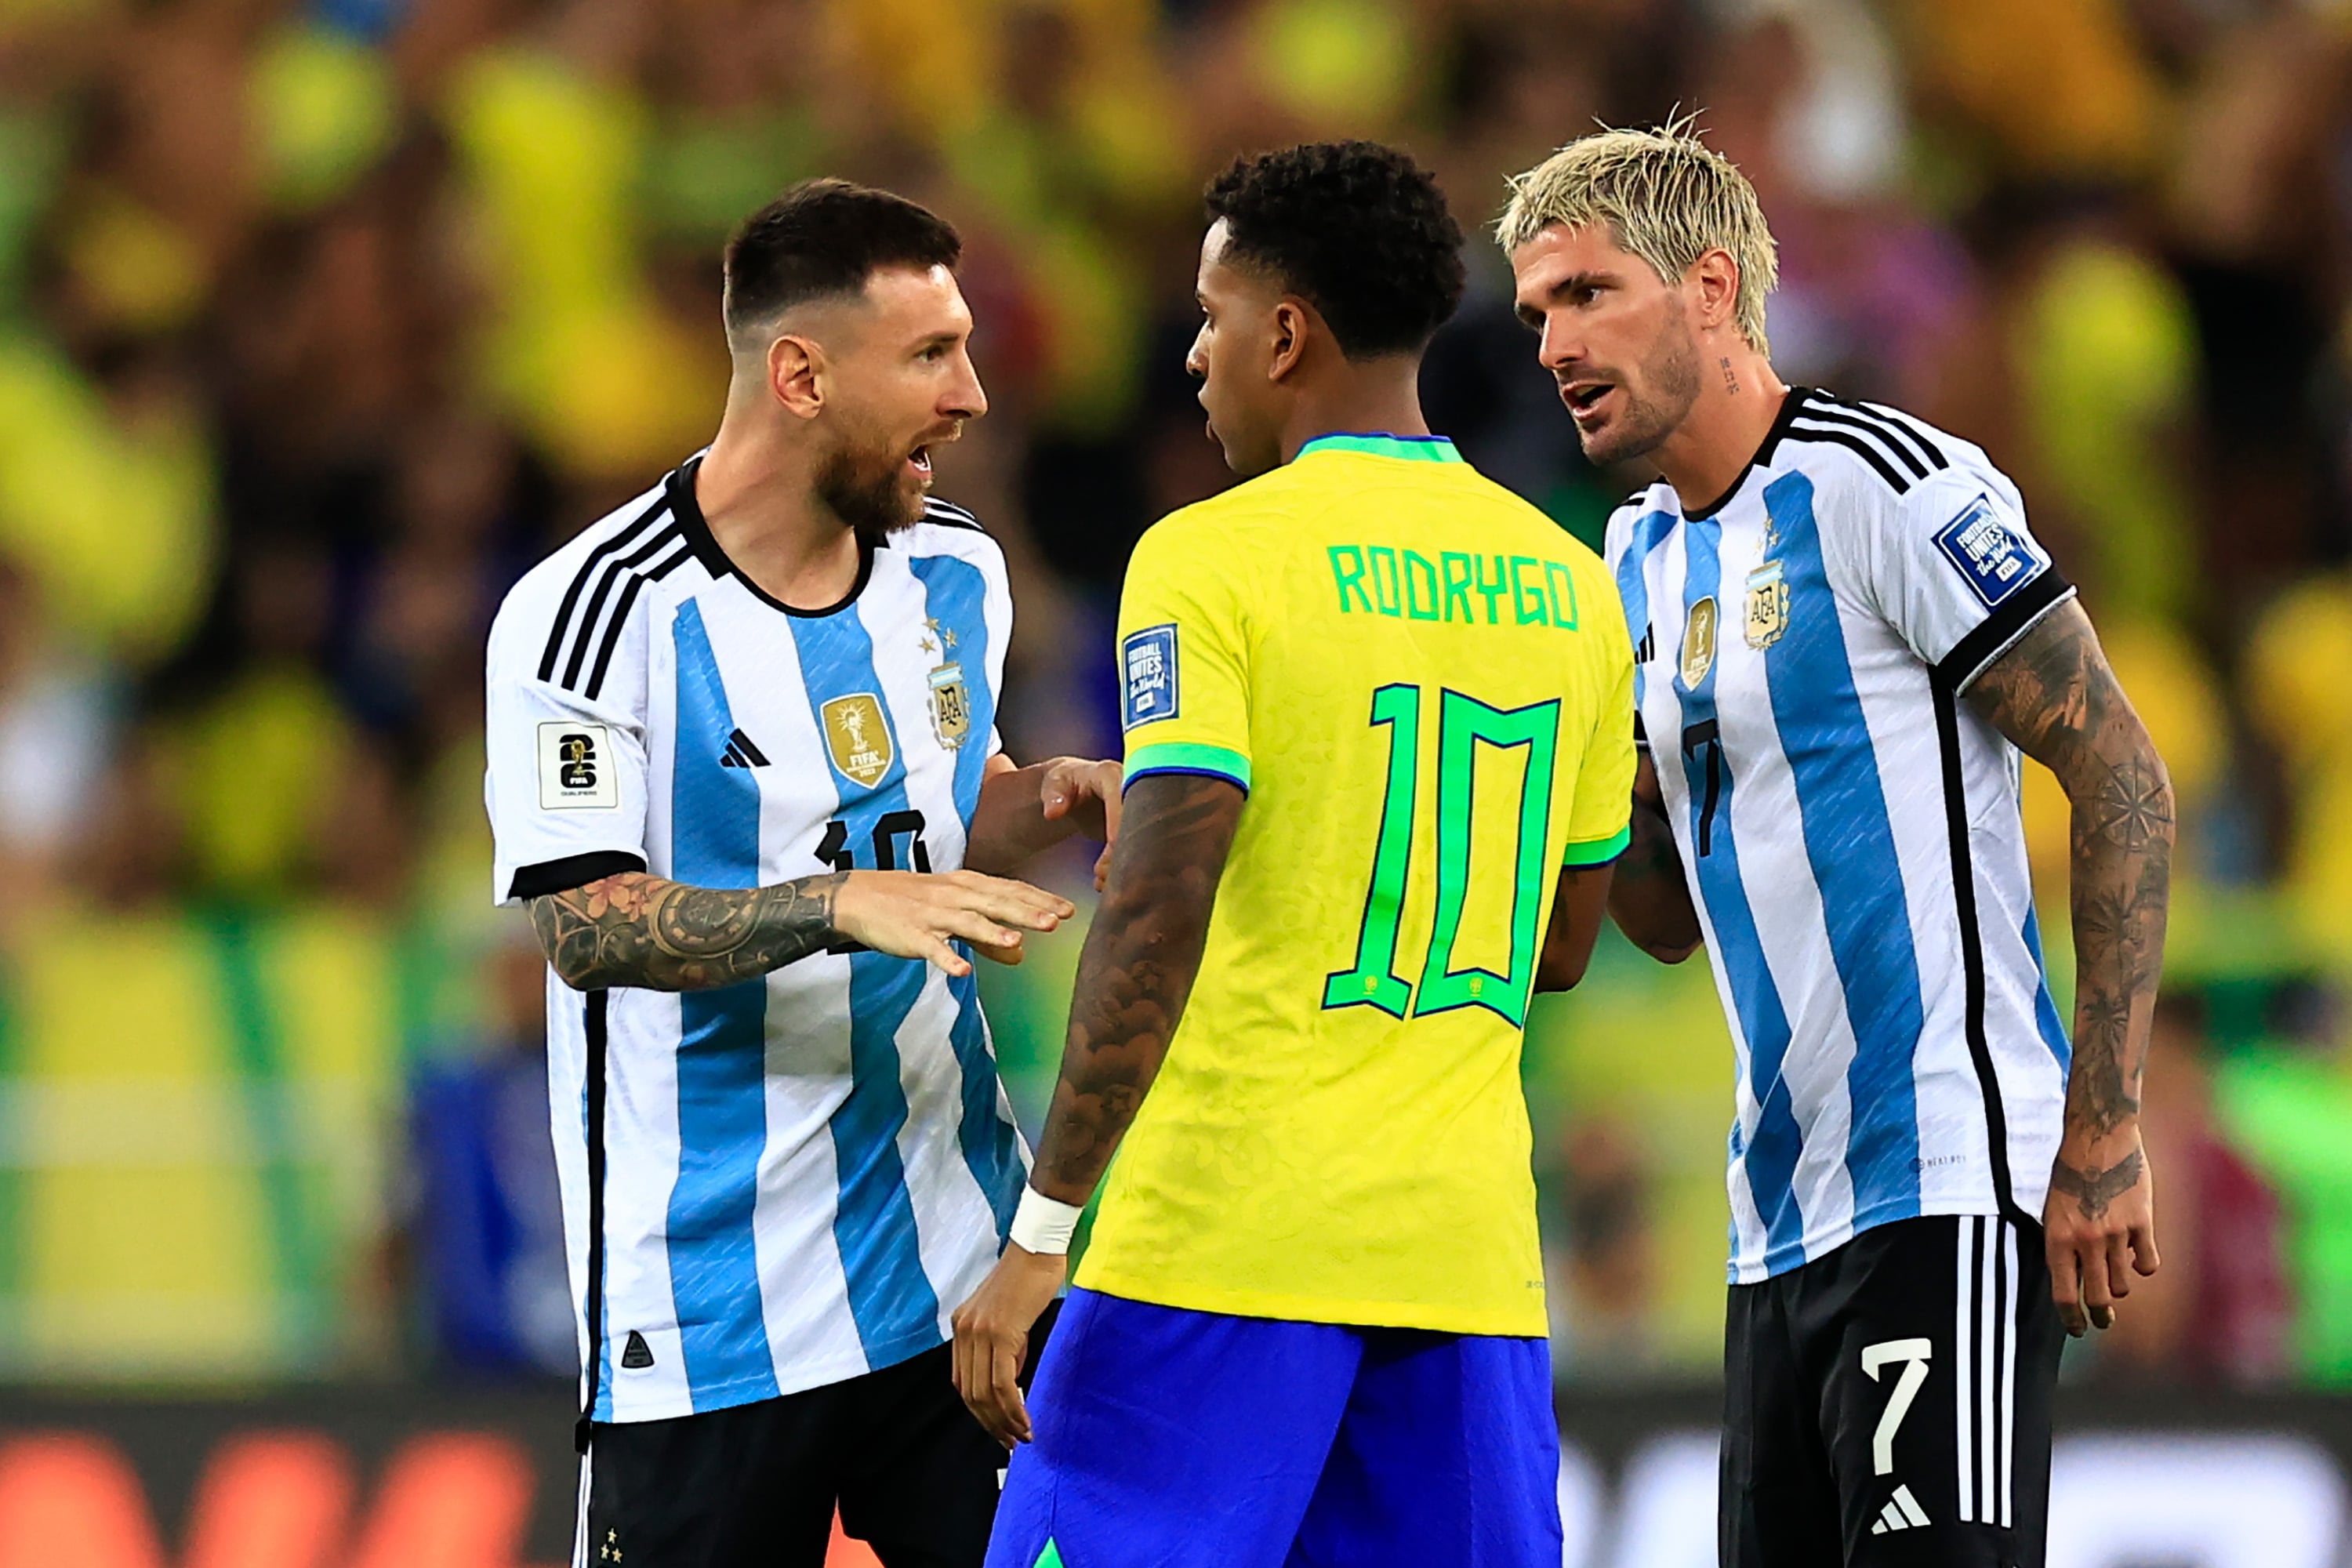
[532,872,842,992]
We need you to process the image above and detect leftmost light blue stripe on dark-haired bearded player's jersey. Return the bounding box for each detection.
[663,600,776,1410]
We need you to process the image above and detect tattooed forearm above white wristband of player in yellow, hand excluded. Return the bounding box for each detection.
[1030,774,1242,1203]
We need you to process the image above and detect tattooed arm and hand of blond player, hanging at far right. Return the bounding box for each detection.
[1969,602,2173,1335]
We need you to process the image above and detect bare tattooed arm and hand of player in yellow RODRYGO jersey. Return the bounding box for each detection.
[955,774,1244,1446]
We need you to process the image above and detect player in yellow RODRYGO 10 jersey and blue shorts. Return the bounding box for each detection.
[955,141,1635,1568]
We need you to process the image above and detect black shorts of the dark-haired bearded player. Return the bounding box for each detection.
[586,1335,1011,1568]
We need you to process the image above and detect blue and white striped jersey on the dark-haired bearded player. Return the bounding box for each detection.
[487,463,1028,1422]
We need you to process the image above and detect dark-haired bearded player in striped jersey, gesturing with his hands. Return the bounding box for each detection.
[487,181,1117,1568]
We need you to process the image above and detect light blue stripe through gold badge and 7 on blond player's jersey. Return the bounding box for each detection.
[1649,517,1804,1272]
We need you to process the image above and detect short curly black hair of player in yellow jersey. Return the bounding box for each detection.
[1207,141,1465,360]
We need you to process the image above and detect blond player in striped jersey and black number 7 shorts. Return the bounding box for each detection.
[1498,125,2173,1568]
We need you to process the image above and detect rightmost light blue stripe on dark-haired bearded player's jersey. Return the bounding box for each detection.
[908,555,1025,1241]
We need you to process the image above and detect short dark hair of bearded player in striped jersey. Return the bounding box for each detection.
[727,179,964,334]
